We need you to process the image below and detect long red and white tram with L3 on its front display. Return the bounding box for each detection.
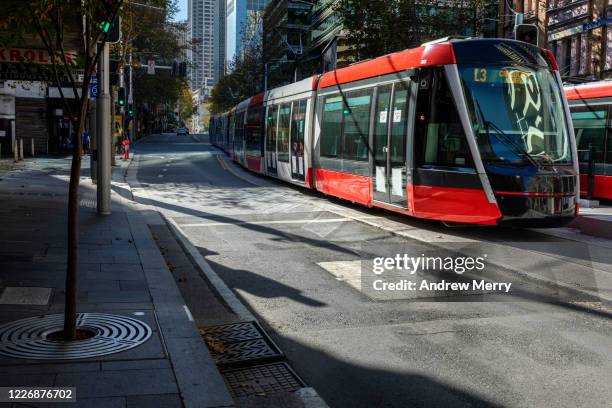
[210,39,579,226]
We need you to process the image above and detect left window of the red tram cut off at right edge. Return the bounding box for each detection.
[572,108,607,163]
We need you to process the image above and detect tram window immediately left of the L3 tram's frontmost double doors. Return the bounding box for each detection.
[342,89,372,160]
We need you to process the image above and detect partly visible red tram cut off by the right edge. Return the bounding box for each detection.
[565,81,612,200]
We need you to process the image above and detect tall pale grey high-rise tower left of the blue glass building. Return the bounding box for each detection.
[188,0,225,98]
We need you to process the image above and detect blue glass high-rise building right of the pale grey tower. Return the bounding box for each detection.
[225,0,269,63]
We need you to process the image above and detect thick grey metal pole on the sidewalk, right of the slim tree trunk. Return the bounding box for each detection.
[96,43,112,215]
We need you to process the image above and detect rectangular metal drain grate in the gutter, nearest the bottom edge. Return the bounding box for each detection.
[221,363,304,398]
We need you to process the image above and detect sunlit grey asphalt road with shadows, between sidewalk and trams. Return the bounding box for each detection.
[129,135,612,408]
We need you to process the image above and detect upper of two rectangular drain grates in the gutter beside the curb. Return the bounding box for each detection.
[200,322,283,367]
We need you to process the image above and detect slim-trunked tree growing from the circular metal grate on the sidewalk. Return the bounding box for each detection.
[0,0,122,341]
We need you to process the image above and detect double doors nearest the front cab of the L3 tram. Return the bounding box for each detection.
[372,82,410,208]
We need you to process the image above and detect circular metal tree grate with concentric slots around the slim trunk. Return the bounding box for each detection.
[0,313,152,360]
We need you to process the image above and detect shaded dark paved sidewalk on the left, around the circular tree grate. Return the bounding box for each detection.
[0,158,233,408]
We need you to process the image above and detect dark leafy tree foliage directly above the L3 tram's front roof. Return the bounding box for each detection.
[335,0,491,62]
